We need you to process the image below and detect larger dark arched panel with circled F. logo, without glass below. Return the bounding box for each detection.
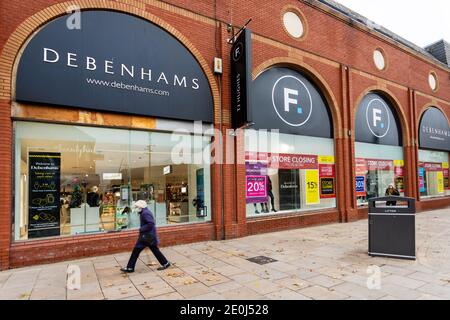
[250,68,333,138]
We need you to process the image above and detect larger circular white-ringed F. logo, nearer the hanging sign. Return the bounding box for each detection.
[272,76,313,127]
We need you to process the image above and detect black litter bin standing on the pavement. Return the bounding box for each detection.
[369,197,416,260]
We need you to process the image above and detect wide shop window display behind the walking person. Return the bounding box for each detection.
[14,122,211,240]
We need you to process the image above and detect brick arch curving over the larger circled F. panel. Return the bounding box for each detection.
[252,57,342,139]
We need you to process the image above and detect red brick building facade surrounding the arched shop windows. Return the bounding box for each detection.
[0,0,450,269]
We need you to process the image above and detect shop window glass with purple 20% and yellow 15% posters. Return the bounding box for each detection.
[246,134,336,217]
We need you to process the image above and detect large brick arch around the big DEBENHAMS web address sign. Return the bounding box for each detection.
[0,0,220,118]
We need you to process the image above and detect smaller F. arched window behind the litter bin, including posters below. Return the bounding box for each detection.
[355,92,404,205]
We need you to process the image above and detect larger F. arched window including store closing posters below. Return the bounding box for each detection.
[245,67,336,217]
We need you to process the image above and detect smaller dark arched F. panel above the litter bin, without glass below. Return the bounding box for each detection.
[355,93,402,146]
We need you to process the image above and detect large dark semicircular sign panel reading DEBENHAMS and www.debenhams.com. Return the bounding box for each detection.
[16,10,213,122]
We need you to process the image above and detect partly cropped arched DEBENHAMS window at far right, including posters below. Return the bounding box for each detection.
[418,107,450,198]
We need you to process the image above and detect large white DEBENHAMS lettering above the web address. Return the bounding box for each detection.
[43,48,200,90]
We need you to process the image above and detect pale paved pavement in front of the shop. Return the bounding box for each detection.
[0,209,450,300]
